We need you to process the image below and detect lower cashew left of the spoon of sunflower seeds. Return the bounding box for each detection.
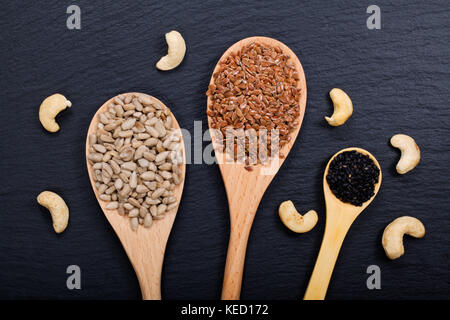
[37,191,69,233]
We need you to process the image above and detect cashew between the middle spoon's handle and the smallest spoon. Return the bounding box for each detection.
[278,200,318,233]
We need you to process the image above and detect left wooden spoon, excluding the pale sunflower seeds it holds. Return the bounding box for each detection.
[86,92,186,300]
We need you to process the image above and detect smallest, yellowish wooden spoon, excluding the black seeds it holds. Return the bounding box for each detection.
[304,148,381,300]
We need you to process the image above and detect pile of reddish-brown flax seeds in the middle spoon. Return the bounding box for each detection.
[206,43,301,169]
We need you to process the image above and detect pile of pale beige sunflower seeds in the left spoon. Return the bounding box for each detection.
[88,94,183,230]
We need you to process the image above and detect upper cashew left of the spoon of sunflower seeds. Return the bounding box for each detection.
[39,93,72,132]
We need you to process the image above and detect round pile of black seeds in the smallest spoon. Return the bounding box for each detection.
[327,150,380,206]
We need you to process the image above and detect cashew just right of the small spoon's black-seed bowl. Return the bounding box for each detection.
[391,134,420,174]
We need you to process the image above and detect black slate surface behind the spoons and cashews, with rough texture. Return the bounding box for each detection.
[0,0,450,299]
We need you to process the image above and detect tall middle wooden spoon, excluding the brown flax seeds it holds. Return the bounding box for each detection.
[208,37,306,300]
